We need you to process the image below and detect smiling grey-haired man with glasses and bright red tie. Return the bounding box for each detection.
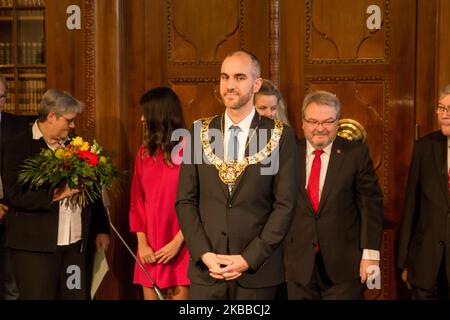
[285,91,383,299]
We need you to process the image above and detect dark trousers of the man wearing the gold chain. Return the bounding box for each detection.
[189,280,278,300]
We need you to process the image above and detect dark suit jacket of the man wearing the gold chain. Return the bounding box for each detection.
[176,113,297,288]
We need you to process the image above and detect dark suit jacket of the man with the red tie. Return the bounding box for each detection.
[285,137,383,285]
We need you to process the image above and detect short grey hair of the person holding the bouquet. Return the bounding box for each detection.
[38,89,84,122]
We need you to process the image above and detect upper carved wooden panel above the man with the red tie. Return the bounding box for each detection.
[306,0,389,63]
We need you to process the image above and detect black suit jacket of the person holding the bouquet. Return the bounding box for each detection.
[2,128,109,252]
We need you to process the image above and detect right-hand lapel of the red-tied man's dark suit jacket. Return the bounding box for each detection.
[318,137,344,212]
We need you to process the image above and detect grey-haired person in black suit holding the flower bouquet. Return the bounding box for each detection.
[2,89,109,299]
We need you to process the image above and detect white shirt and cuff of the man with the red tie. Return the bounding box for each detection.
[305,140,380,261]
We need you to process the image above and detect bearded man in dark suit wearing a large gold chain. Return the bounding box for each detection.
[176,51,297,299]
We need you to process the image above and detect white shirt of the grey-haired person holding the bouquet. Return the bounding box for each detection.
[32,120,82,246]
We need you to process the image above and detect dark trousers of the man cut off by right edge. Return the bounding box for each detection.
[411,254,450,300]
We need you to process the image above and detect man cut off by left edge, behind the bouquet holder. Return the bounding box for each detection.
[0,76,28,300]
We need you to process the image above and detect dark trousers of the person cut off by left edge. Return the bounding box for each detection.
[0,224,19,300]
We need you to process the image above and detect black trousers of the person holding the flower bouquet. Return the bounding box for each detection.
[11,242,90,300]
